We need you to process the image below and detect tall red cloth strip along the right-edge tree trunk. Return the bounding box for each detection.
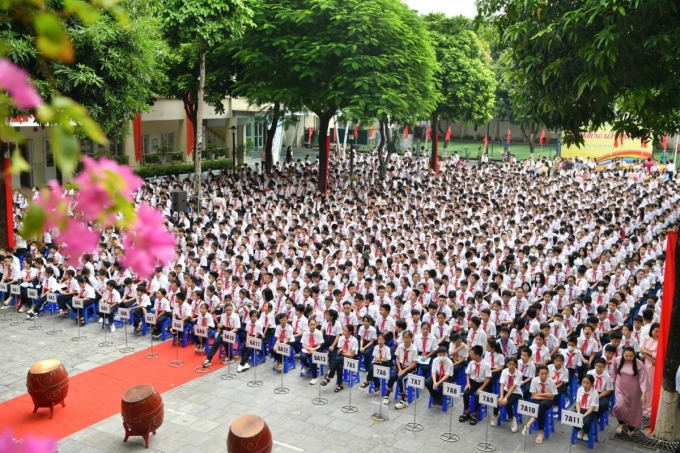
[649,231,678,433]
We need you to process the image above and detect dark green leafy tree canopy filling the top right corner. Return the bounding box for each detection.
[477,0,680,144]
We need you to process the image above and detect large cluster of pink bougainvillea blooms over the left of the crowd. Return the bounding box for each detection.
[36,157,175,278]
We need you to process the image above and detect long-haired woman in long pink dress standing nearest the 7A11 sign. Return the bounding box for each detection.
[612,346,651,436]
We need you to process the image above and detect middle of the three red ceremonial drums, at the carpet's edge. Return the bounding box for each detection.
[120,384,164,448]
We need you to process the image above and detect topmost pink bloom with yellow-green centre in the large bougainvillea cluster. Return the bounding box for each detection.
[73,156,143,224]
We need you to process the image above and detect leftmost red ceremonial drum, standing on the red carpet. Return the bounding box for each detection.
[26,359,68,418]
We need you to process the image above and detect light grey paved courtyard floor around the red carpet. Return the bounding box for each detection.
[0,311,649,453]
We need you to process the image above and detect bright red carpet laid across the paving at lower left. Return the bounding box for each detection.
[0,341,225,439]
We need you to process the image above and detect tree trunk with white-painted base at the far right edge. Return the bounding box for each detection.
[652,228,680,442]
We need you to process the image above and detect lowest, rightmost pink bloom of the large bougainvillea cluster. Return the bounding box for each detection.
[122,204,175,278]
